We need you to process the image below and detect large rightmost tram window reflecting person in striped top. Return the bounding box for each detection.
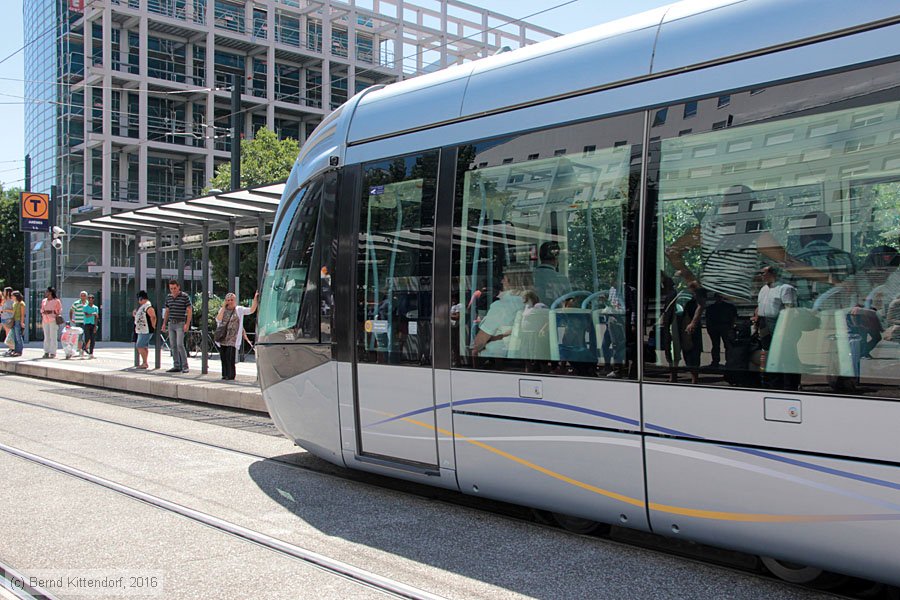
[645,64,900,398]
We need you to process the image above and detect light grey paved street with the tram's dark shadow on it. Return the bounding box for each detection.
[0,375,836,599]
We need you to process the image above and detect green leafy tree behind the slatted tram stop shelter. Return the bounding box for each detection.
[205,127,300,300]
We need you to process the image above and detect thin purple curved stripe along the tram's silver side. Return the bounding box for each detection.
[366,397,900,490]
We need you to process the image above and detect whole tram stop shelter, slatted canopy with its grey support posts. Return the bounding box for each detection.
[72,183,285,375]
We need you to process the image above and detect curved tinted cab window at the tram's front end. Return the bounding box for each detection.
[258,180,323,343]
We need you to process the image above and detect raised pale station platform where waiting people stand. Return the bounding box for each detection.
[0,342,267,412]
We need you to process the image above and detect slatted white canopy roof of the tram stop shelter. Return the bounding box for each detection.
[72,183,285,236]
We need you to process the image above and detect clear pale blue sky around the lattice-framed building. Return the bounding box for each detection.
[0,0,673,188]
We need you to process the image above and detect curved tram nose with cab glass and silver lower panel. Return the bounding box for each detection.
[256,109,343,465]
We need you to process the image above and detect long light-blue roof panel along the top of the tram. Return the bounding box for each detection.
[343,0,898,144]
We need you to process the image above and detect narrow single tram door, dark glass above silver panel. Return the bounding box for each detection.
[355,151,439,465]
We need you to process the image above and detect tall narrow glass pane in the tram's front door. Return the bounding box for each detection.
[356,151,438,365]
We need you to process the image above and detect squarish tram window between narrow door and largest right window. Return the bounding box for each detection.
[450,115,642,377]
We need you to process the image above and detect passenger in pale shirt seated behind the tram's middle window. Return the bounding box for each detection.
[472,263,533,358]
